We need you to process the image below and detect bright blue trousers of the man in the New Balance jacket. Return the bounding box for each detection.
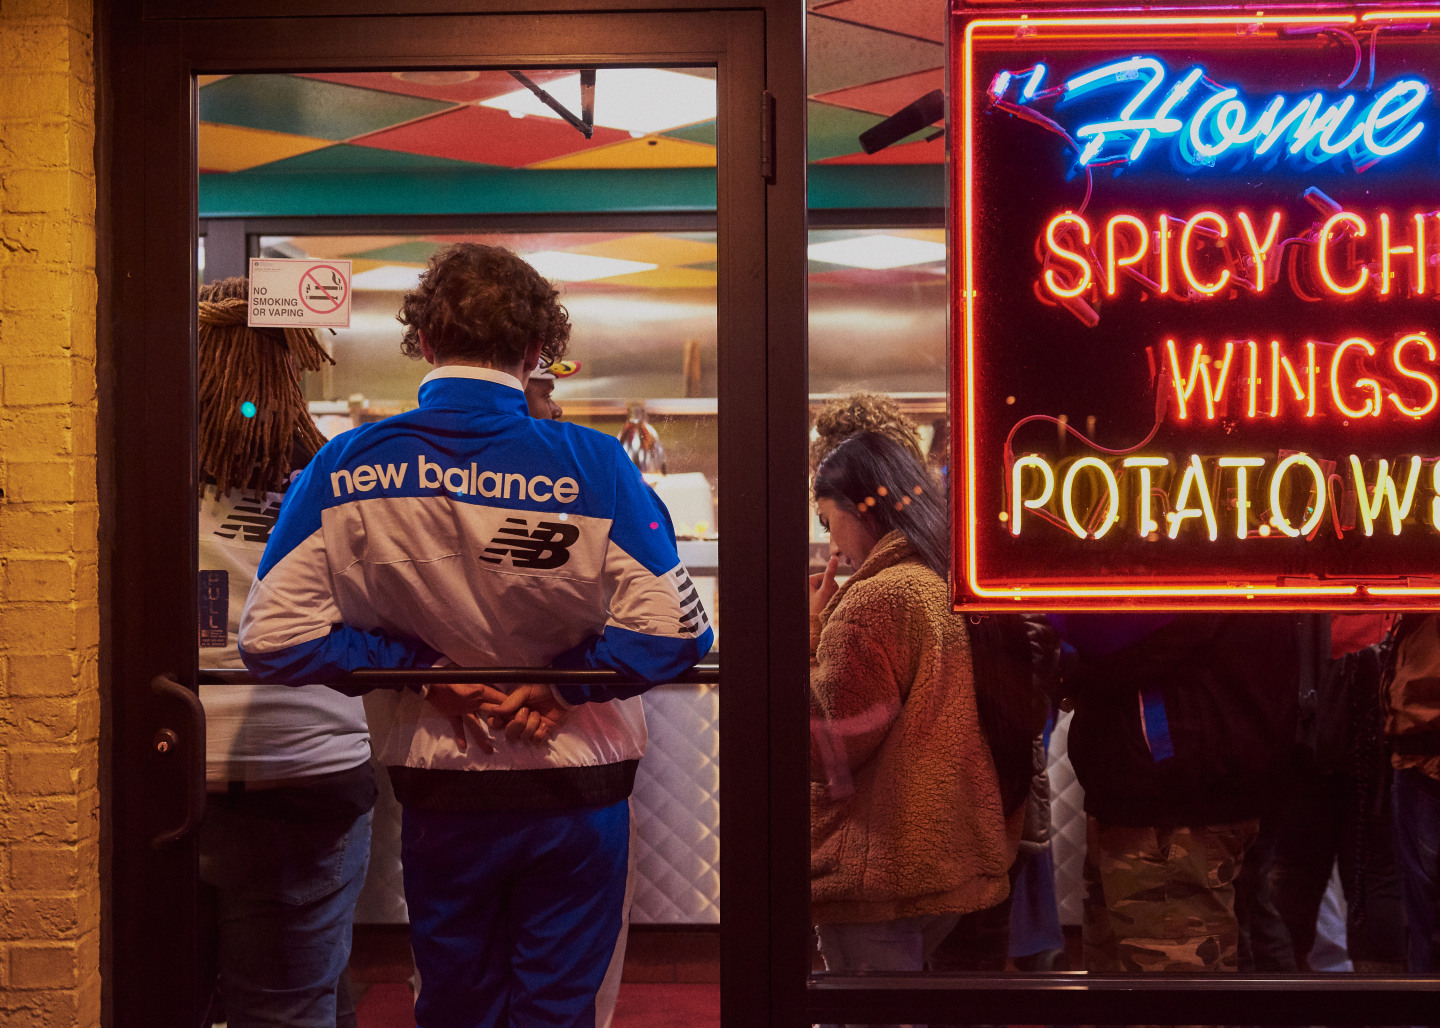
[400,799,629,1028]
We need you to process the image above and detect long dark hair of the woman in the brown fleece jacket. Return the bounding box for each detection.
[815,432,950,579]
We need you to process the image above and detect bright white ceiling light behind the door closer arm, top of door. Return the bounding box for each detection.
[480,68,716,135]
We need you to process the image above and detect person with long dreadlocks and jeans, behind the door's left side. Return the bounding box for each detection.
[199,278,376,1028]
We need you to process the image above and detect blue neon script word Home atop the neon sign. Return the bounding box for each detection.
[988,56,1430,171]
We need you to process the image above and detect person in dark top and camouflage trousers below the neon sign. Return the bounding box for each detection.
[1057,613,1299,972]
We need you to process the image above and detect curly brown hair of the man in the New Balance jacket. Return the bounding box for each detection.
[396,243,570,370]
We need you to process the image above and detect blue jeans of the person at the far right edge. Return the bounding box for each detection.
[1391,767,1440,975]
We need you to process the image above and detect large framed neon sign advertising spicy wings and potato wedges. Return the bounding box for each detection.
[950,10,1440,609]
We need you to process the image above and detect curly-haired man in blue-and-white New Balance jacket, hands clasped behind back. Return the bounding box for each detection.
[240,243,713,1028]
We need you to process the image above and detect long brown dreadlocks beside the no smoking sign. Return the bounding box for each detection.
[199,278,336,495]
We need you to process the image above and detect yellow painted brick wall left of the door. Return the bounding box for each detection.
[0,0,99,1028]
